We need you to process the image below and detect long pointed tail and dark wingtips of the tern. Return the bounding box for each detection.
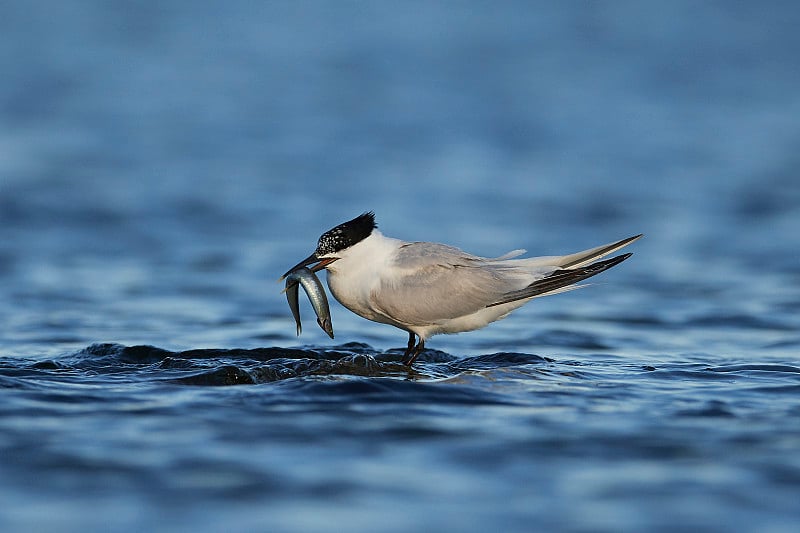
[486,235,641,307]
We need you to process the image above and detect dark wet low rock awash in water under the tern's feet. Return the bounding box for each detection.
[5,343,553,386]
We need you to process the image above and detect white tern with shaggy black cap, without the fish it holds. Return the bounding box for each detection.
[281,212,641,366]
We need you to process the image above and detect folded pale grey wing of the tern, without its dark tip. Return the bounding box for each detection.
[372,243,524,326]
